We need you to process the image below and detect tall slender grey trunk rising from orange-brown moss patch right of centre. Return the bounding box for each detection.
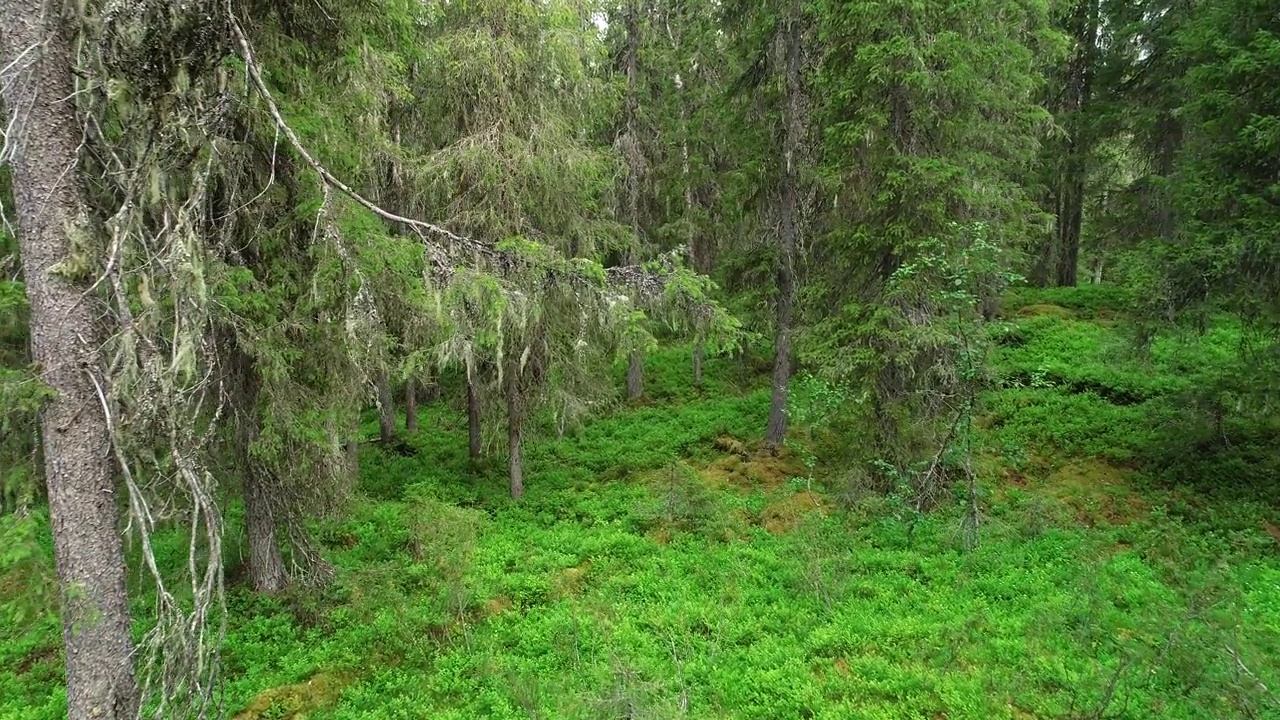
[764,0,804,447]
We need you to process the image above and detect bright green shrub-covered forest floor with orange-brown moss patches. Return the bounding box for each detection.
[0,288,1280,720]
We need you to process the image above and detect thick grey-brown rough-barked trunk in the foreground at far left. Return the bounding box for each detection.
[0,0,138,720]
